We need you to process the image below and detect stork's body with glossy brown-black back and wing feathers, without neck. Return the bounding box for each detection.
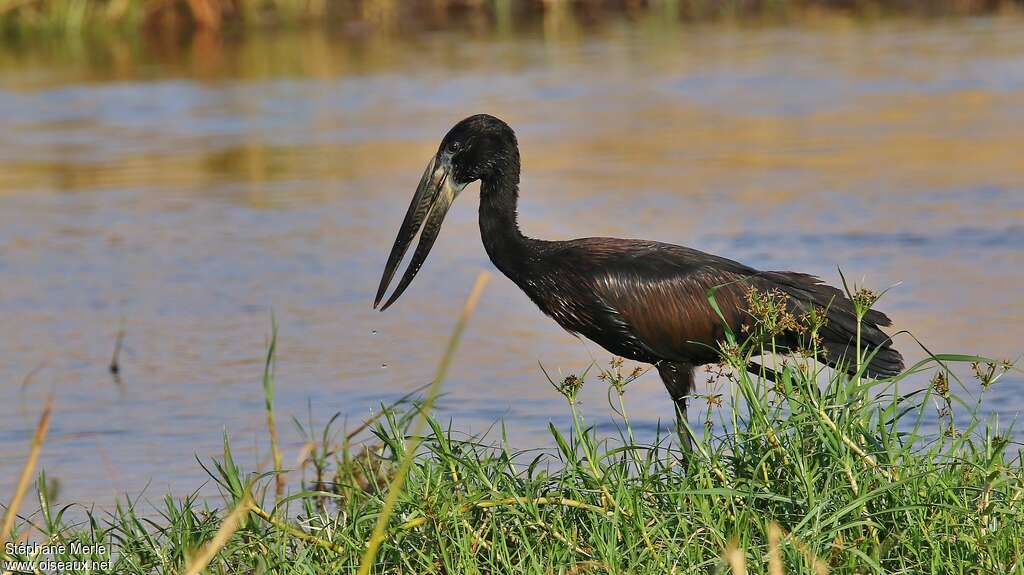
[519,237,902,374]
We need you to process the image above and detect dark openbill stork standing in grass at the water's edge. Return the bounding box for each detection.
[374,114,903,433]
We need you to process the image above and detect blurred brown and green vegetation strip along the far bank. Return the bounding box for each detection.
[0,0,1021,36]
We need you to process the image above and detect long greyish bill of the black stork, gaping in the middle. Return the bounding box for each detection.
[374,156,466,311]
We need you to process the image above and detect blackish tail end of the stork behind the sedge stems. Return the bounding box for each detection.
[753,271,903,378]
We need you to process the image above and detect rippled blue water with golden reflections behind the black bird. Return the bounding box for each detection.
[0,13,1024,505]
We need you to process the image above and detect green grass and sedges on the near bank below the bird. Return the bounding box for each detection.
[0,276,1024,575]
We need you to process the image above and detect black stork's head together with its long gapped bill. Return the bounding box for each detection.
[374,114,519,311]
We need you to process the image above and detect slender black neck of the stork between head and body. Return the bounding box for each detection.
[480,157,535,280]
